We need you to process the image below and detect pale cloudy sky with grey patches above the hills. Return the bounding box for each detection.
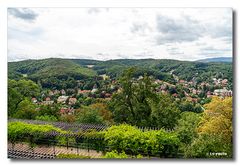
[8,8,232,61]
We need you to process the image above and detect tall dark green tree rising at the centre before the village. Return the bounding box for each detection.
[110,68,156,126]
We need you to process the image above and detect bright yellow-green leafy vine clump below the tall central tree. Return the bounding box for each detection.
[104,124,180,157]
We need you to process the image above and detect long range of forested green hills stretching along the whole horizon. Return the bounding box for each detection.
[8,58,233,89]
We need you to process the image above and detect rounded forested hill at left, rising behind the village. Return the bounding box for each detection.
[8,58,96,89]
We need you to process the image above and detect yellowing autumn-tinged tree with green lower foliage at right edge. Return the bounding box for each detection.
[186,97,233,158]
